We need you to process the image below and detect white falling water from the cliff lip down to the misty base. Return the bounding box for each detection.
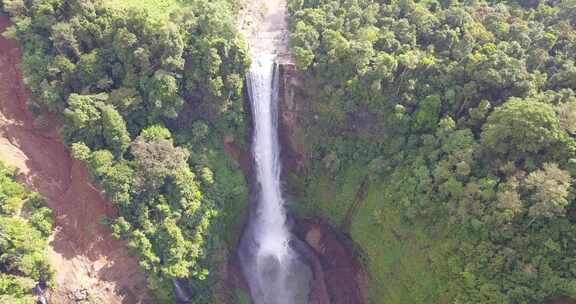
[240,56,311,304]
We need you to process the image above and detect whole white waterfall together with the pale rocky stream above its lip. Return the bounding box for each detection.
[239,1,312,304]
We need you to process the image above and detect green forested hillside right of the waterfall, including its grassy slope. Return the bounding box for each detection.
[289,0,576,304]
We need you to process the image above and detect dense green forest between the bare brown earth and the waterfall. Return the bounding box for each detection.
[0,0,248,303]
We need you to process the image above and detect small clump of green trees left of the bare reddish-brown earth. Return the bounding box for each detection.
[0,163,52,304]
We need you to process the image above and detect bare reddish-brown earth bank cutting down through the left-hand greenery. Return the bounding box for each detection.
[0,16,151,304]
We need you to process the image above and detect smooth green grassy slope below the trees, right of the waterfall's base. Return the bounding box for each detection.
[351,182,447,304]
